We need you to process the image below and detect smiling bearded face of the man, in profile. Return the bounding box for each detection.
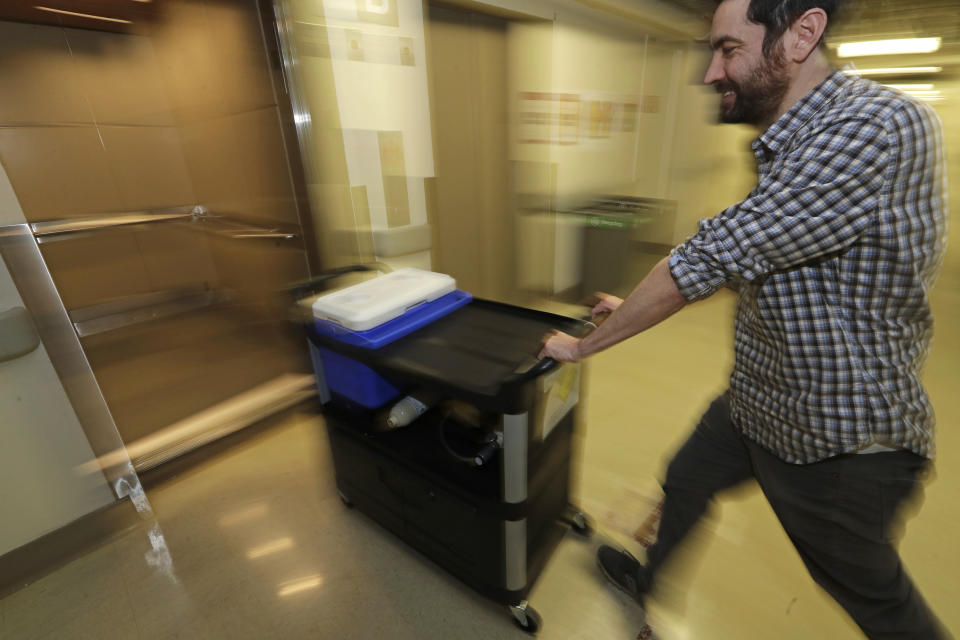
[703,0,790,125]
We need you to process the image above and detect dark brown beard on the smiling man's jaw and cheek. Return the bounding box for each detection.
[717,43,790,125]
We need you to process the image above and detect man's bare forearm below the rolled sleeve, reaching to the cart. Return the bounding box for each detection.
[580,258,687,358]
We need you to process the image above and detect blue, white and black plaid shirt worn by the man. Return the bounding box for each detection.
[670,71,947,464]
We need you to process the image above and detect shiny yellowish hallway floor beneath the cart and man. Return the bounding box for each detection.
[0,280,960,640]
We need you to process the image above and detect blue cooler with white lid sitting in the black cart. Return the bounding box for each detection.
[310,269,473,409]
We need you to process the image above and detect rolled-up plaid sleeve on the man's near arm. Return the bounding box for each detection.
[669,118,893,302]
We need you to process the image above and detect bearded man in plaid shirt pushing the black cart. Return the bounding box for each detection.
[541,0,946,640]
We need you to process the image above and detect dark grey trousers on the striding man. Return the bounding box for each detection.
[647,396,950,640]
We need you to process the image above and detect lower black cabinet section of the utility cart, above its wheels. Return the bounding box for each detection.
[326,408,590,633]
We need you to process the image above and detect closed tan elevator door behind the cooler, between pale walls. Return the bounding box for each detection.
[429,6,515,300]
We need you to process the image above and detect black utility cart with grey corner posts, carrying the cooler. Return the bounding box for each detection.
[307,268,589,633]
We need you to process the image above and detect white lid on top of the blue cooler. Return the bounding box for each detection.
[313,268,457,331]
